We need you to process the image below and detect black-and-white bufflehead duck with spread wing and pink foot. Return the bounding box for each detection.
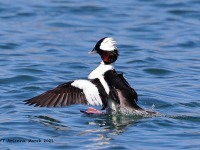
[25,37,151,114]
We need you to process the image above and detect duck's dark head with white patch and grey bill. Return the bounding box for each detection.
[89,37,119,64]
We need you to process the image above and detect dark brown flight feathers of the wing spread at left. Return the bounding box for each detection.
[25,82,87,107]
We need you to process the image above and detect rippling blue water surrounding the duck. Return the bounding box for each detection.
[0,0,200,150]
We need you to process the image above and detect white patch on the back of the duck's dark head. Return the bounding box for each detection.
[100,37,117,51]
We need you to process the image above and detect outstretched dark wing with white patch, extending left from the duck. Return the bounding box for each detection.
[25,80,107,107]
